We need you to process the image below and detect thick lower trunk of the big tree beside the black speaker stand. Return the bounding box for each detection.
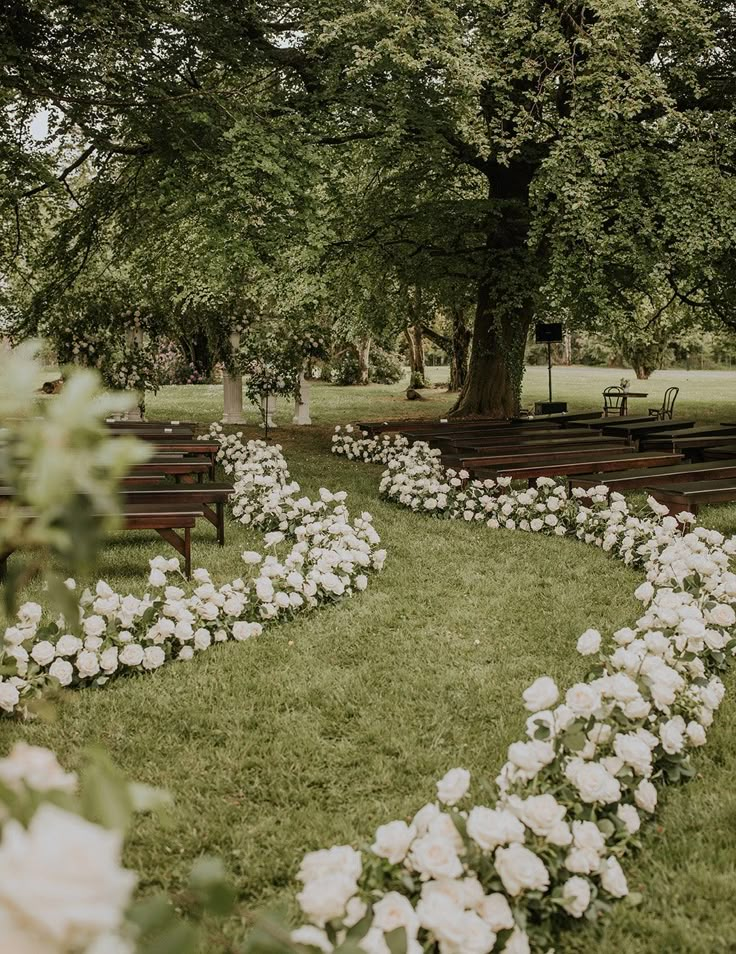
[450,283,532,418]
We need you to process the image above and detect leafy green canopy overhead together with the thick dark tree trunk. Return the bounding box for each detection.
[0,0,736,415]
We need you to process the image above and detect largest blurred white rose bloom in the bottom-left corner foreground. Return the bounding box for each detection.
[0,804,136,950]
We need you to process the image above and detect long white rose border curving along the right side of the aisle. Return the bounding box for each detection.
[294,428,736,954]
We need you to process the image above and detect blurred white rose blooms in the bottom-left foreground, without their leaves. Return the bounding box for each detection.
[0,742,137,954]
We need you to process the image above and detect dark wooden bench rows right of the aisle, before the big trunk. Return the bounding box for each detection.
[359,411,736,512]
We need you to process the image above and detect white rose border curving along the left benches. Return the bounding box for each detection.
[0,424,386,713]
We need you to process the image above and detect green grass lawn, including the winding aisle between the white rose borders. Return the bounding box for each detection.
[0,368,736,954]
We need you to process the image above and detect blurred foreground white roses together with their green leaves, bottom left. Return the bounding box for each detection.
[0,742,233,954]
